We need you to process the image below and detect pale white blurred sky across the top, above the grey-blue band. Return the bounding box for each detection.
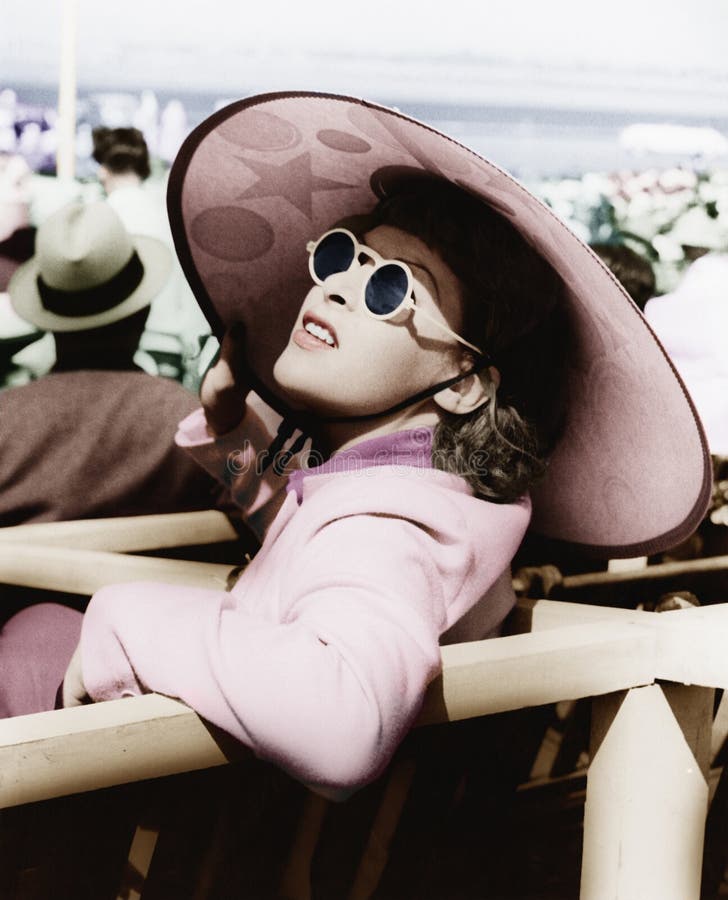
[0,0,728,96]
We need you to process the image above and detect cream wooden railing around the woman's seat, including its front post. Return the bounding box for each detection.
[0,513,728,900]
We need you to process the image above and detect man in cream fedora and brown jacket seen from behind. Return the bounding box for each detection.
[0,202,228,526]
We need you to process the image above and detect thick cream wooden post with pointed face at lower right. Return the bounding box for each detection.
[580,684,713,900]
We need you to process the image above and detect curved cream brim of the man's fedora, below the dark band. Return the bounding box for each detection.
[8,235,173,331]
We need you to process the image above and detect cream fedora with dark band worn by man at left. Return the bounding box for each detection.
[8,201,172,331]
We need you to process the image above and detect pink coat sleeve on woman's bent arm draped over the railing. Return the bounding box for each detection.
[81,515,456,795]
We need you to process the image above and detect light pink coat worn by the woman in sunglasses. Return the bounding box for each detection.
[81,411,530,795]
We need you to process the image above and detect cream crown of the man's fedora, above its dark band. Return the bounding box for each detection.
[36,201,134,293]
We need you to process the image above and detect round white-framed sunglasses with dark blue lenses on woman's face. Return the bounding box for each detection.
[306,228,483,356]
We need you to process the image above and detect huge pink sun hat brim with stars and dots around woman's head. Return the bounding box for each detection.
[167,92,711,556]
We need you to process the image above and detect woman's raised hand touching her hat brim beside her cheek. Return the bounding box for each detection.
[200,323,250,436]
